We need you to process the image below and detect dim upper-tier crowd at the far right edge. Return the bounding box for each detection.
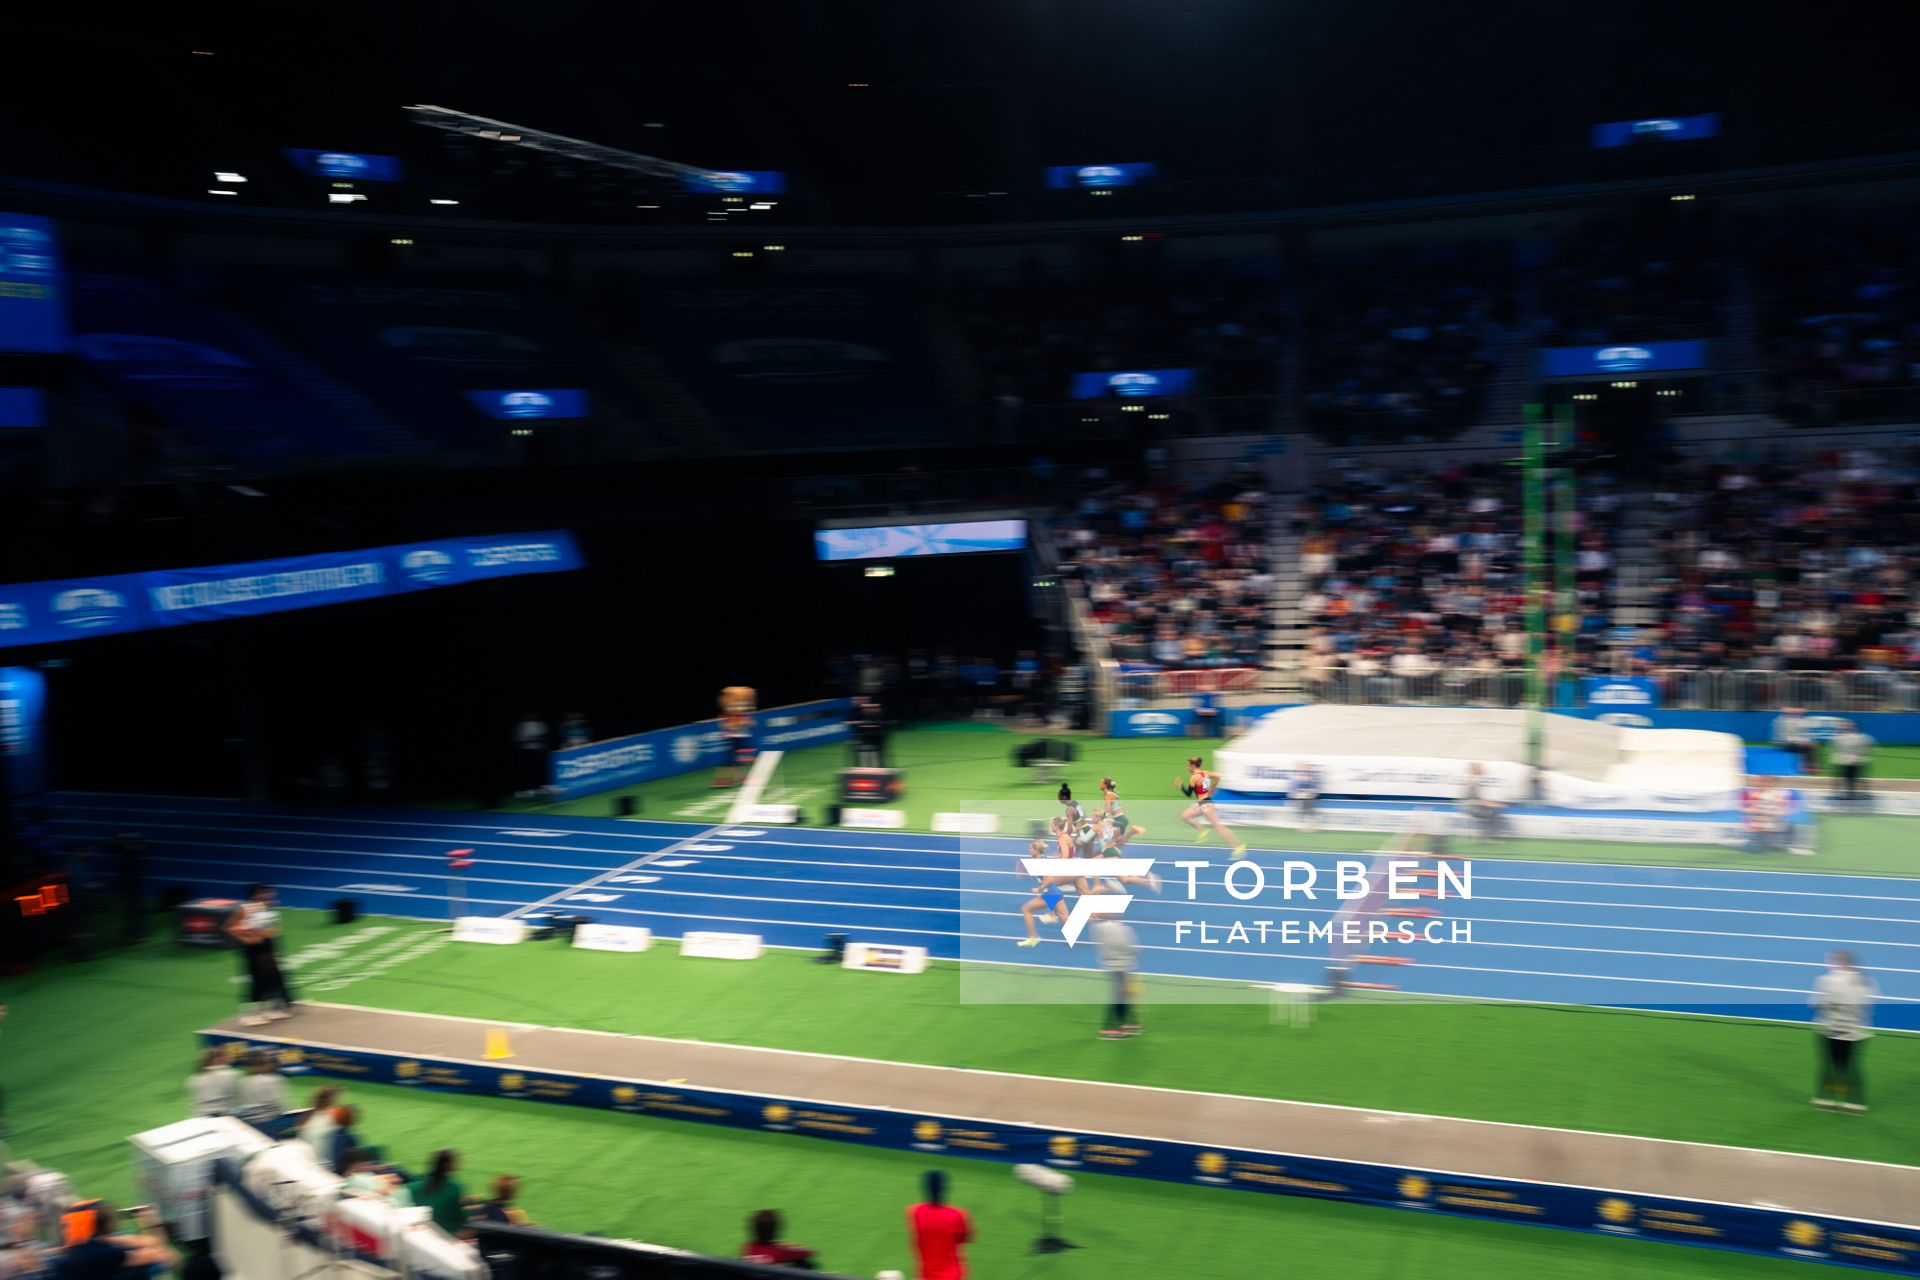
[1749,209,1920,424]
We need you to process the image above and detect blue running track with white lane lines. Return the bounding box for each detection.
[56,794,1920,1031]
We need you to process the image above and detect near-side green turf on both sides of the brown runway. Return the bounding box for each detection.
[0,912,1843,1280]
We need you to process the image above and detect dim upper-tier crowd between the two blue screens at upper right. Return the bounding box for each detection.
[1540,214,1726,345]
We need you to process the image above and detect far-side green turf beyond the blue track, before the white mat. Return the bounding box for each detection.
[491,722,1920,875]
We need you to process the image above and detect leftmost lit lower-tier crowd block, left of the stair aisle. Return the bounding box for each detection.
[1056,482,1273,668]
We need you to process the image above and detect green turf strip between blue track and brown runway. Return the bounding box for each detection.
[11,912,1920,1163]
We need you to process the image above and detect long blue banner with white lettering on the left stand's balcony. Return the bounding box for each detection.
[0,530,586,647]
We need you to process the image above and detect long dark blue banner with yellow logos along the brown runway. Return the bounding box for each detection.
[202,1032,1920,1274]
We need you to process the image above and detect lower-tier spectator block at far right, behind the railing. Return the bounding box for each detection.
[1636,449,1920,672]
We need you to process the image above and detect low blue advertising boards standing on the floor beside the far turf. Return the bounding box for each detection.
[547,699,852,800]
